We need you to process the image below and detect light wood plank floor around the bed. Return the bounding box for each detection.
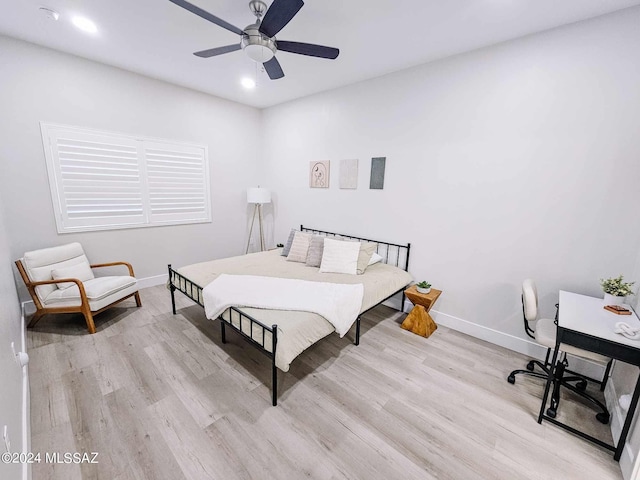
[28,287,621,480]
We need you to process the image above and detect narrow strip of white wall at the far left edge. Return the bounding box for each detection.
[0,196,27,479]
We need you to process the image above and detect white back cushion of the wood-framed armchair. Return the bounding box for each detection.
[22,242,89,302]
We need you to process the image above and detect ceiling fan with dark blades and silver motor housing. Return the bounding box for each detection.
[169,0,340,80]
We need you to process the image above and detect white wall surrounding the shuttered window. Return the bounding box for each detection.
[0,37,260,288]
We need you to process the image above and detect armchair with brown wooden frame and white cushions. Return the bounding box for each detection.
[16,243,142,333]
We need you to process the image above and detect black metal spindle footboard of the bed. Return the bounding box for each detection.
[168,265,282,406]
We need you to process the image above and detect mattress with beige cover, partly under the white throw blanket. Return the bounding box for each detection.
[175,249,412,372]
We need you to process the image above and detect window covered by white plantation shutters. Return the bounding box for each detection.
[40,123,211,233]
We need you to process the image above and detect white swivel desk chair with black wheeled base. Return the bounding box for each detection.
[507,279,612,424]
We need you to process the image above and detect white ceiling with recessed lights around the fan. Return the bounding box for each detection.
[0,0,640,107]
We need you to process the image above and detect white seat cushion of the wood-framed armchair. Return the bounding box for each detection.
[43,275,138,311]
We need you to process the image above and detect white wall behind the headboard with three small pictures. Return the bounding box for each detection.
[263,8,640,338]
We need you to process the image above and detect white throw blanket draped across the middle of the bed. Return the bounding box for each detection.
[202,274,364,337]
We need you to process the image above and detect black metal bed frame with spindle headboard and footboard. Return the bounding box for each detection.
[168,225,411,406]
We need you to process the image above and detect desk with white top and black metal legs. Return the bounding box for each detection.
[538,291,640,461]
